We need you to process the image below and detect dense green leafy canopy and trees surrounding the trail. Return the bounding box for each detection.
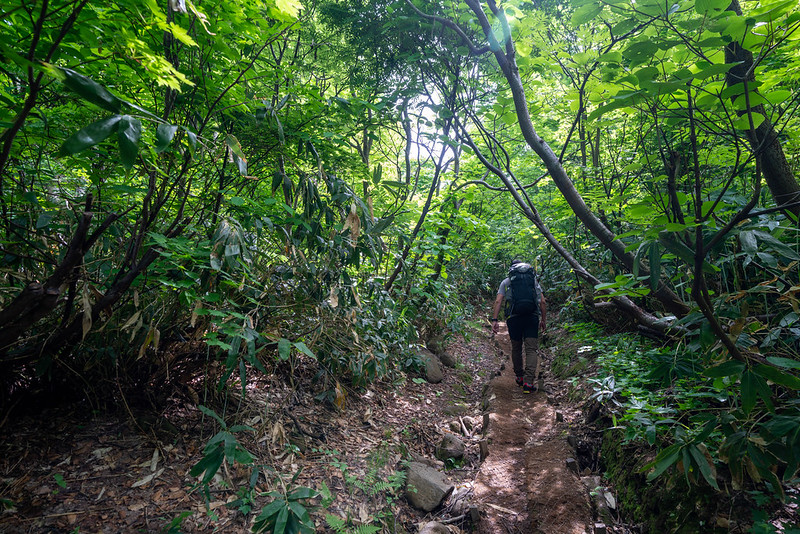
[0,0,800,528]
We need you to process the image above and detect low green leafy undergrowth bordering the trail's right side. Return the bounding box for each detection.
[554,323,800,532]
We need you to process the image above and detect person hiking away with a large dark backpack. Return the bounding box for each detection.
[492,260,547,393]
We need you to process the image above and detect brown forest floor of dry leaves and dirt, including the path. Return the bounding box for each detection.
[0,324,622,534]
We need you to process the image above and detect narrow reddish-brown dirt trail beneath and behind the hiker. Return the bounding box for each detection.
[474,328,592,534]
